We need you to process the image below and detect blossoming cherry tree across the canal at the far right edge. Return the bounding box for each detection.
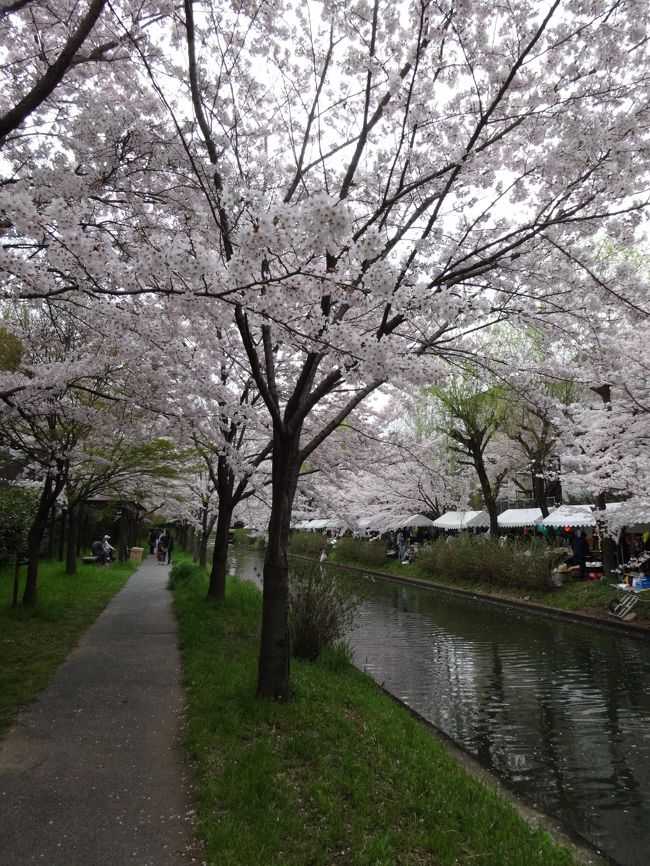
[547,240,650,576]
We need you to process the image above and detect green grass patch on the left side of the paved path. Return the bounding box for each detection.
[0,562,135,736]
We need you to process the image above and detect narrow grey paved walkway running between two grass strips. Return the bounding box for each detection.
[0,559,199,866]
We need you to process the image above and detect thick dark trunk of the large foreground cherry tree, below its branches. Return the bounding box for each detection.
[257,431,300,701]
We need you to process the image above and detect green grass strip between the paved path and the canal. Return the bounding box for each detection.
[174,560,574,866]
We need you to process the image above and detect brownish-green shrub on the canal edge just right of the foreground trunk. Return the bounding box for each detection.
[289,565,358,663]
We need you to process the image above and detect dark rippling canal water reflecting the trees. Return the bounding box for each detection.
[228,551,650,866]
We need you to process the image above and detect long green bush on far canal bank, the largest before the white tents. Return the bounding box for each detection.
[417,535,553,589]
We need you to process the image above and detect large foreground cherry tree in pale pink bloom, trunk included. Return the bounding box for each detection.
[0,0,650,699]
